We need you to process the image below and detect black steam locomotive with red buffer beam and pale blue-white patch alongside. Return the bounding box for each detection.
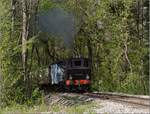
[49,58,91,91]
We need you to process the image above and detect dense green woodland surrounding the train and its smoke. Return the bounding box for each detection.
[0,0,149,106]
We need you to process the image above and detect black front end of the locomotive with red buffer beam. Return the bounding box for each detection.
[65,58,91,90]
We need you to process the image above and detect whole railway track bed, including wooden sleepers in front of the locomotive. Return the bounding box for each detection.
[46,92,150,108]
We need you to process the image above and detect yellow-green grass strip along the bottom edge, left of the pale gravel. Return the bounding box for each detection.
[0,103,96,114]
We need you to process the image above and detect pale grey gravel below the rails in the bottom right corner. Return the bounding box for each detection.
[95,99,150,114]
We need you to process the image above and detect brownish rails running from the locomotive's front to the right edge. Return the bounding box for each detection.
[84,92,150,108]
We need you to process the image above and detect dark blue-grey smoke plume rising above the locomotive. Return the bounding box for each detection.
[38,8,77,47]
